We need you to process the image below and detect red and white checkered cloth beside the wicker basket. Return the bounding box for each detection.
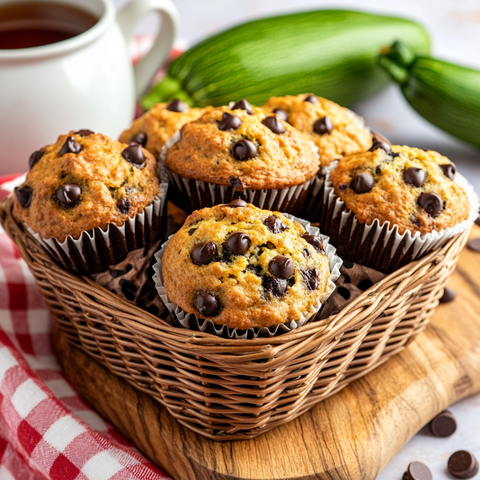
[0,177,169,480]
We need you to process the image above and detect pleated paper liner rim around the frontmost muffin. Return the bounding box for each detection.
[153,214,343,339]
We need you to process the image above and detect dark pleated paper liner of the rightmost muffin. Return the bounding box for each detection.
[320,162,479,273]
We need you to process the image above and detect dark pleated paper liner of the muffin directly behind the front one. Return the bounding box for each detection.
[159,130,321,215]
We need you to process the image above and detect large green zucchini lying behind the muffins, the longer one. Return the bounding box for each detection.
[142,10,430,109]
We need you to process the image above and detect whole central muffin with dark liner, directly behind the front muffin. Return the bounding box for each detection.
[165,100,320,213]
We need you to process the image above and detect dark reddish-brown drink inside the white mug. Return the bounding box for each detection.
[0,2,98,50]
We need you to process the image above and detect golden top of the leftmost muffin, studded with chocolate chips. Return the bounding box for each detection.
[14,130,160,242]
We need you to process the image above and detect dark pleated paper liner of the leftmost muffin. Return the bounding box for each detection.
[27,181,168,276]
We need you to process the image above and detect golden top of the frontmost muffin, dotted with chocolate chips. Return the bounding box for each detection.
[162,199,330,329]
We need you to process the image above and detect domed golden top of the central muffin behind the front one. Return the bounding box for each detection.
[166,100,319,189]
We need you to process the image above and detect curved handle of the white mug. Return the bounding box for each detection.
[117,0,179,99]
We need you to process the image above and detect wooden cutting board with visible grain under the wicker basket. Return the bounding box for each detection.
[50,227,480,480]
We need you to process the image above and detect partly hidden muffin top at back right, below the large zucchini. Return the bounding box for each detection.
[262,94,372,167]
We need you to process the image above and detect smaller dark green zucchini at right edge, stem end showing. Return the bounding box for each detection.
[380,42,480,147]
